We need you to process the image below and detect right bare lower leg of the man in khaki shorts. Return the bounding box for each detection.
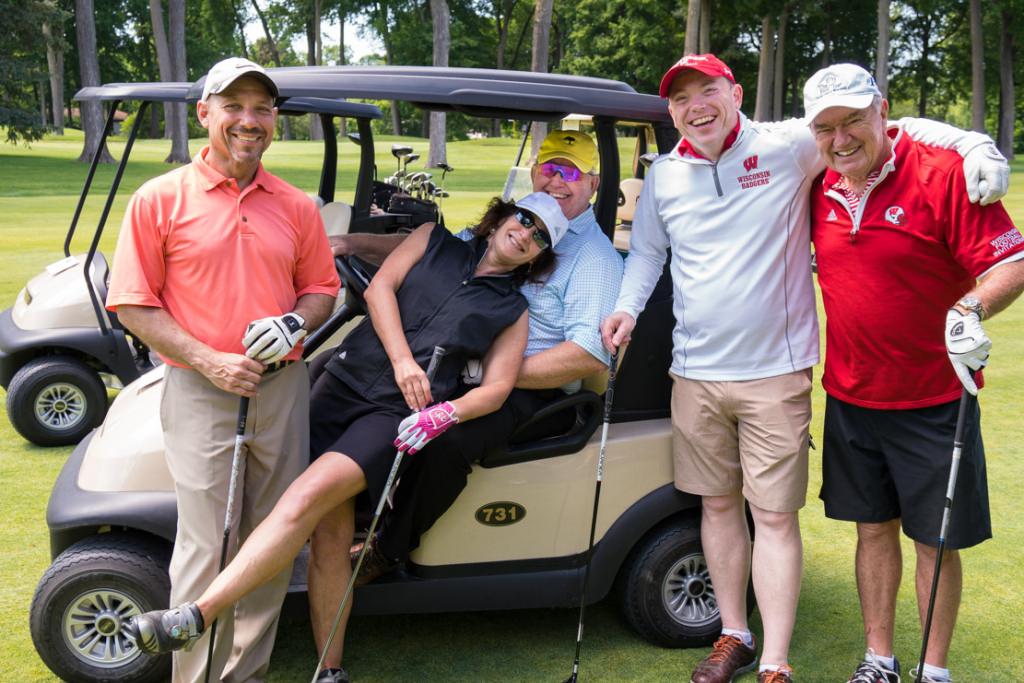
[743,505,804,666]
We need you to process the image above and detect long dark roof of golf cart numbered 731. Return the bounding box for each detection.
[189,67,671,124]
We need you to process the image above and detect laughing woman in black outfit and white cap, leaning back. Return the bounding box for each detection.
[130,193,567,680]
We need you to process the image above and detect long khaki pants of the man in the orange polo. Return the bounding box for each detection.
[160,362,309,683]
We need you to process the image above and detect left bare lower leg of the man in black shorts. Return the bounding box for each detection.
[854,519,903,657]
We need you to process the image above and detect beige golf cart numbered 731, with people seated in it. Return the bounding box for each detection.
[31,67,737,681]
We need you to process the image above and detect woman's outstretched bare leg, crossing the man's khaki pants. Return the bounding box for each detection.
[196,453,367,624]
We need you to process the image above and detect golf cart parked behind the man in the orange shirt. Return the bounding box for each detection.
[0,83,381,445]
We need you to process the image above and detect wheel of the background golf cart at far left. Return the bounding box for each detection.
[7,355,108,445]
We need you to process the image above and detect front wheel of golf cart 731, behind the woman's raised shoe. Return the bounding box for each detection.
[30,533,171,683]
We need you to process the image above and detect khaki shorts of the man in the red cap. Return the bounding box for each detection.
[672,368,811,512]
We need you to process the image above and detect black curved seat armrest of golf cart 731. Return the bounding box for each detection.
[480,389,604,468]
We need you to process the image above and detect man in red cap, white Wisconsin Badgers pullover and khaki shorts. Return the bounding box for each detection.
[601,54,1006,683]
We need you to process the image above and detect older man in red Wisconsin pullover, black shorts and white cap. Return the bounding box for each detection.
[804,65,1024,683]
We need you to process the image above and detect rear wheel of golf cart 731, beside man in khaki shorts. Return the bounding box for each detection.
[616,516,722,647]
